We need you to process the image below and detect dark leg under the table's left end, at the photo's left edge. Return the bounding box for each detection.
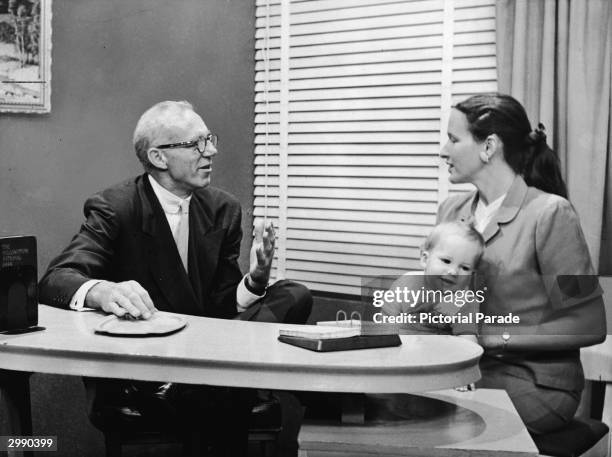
[0,370,32,457]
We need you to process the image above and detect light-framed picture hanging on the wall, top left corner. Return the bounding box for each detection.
[0,0,51,113]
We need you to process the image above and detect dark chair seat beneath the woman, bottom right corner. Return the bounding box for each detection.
[532,418,610,457]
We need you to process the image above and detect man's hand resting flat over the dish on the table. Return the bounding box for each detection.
[85,281,156,319]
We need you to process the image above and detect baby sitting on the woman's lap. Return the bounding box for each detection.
[382,222,484,342]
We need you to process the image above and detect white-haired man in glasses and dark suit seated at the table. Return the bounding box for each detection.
[39,101,311,455]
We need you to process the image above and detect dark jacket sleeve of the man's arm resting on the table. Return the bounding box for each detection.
[39,194,119,308]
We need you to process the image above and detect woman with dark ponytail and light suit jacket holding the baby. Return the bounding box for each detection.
[438,94,606,434]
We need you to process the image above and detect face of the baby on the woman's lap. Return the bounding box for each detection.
[421,235,478,290]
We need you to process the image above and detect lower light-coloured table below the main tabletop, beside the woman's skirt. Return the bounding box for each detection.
[299,389,539,457]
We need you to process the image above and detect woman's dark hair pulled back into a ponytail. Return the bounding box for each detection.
[454,93,567,198]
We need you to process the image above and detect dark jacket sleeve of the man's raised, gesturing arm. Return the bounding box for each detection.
[210,203,242,318]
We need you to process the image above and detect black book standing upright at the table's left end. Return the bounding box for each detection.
[0,236,38,331]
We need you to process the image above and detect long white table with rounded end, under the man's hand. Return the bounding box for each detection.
[0,305,482,454]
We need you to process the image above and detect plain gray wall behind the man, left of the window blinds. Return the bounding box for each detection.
[0,0,255,456]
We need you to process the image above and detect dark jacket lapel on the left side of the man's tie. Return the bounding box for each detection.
[141,175,201,315]
